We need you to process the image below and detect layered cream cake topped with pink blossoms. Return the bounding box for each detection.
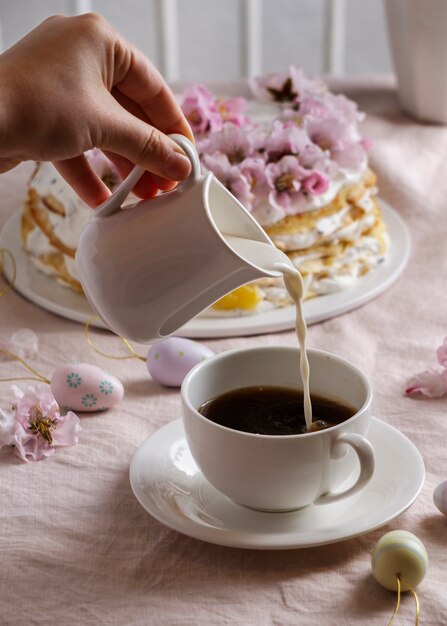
[22,68,388,316]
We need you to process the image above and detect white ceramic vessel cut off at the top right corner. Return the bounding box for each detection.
[385,0,447,124]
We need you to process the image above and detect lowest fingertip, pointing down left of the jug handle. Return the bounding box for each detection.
[53,155,110,207]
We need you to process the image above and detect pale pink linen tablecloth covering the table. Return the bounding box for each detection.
[0,81,447,626]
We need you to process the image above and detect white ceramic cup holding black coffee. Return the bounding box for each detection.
[181,346,374,511]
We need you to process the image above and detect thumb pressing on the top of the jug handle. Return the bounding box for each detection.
[97,97,191,181]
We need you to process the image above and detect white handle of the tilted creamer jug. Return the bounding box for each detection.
[94,133,201,217]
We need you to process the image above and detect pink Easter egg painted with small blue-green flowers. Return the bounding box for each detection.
[51,363,124,412]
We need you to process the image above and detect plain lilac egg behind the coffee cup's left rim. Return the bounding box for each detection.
[146,337,214,387]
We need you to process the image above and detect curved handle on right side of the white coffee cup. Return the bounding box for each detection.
[314,433,375,504]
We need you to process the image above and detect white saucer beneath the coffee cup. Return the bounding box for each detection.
[130,418,425,550]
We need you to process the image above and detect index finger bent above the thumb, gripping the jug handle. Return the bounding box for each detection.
[113,42,194,141]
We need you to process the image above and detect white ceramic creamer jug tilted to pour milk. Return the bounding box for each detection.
[76,135,288,343]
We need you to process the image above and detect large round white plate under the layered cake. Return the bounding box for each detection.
[0,200,410,339]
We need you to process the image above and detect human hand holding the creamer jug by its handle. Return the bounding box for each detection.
[0,13,193,206]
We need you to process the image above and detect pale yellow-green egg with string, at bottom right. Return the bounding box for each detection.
[371,530,428,591]
